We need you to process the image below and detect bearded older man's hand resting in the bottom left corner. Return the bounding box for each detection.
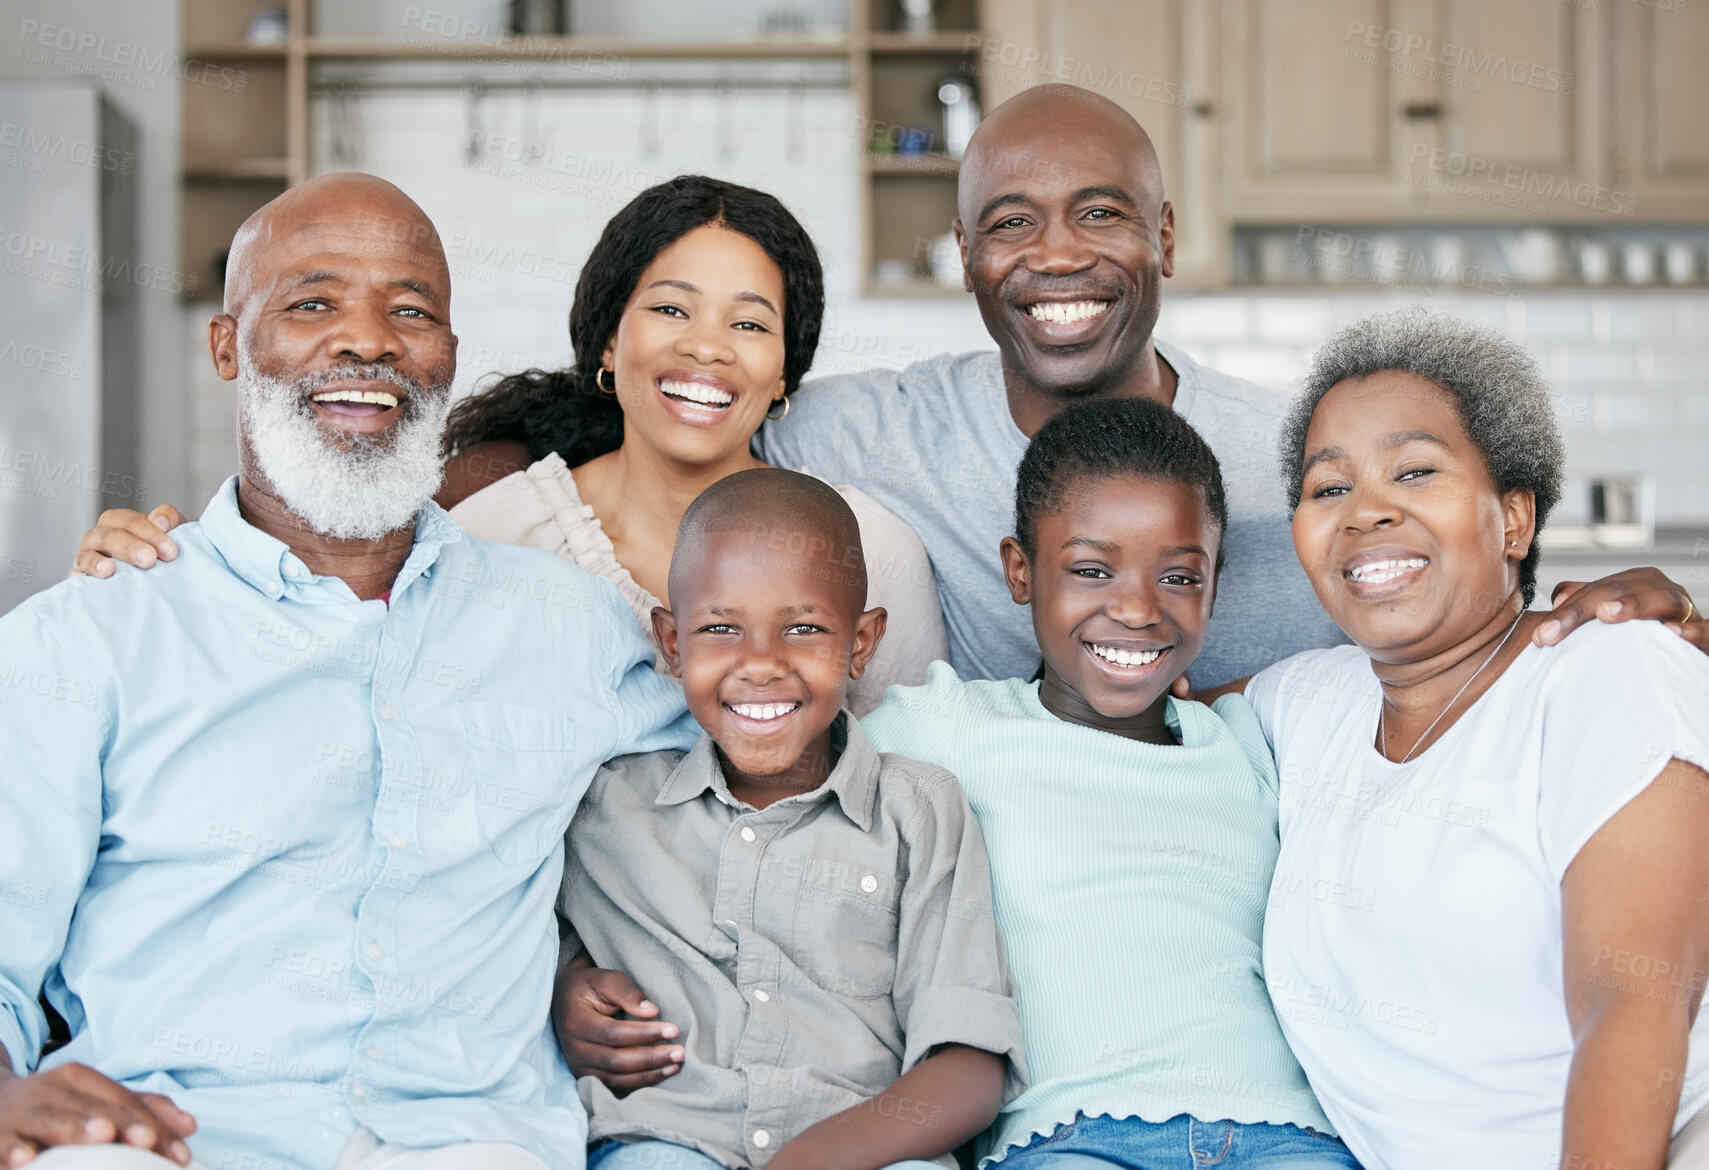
[0,1064,197,1167]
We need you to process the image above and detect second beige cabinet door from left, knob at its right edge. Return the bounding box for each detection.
[1224,0,1434,224]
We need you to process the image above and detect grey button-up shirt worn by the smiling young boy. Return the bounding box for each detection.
[559,714,1024,1167]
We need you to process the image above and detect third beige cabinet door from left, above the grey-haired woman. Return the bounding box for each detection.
[1410,0,1630,222]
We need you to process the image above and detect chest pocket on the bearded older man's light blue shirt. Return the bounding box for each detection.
[458,699,576,866]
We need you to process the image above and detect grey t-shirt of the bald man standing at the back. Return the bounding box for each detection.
[755,342,1347,687]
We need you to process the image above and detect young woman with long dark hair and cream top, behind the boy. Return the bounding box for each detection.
[439,176,948,712]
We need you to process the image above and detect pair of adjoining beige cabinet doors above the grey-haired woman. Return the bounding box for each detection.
[1224,0,1606,224]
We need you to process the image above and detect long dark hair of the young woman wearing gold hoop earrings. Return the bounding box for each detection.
[444,174,825,466]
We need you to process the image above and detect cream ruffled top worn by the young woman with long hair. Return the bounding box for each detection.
[451,451,948,716]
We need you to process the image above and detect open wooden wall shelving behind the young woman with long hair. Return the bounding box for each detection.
[181,0,984,297]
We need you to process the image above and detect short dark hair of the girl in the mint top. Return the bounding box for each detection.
[1015,398,1229,570]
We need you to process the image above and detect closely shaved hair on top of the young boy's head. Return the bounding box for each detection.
[670,468,866,613]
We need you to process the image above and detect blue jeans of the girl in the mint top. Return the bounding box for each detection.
[1000,1114,1359,1170]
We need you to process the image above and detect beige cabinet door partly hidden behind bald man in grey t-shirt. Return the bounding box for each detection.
[981,0,1229,284]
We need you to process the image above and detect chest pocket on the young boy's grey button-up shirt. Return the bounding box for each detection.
[791,857,901,999]
